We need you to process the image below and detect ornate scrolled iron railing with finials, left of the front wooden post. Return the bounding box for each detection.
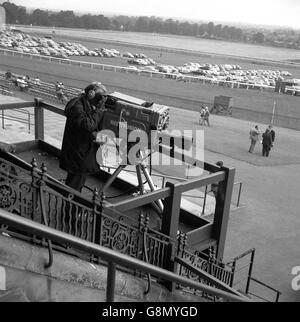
[0,158,170,267]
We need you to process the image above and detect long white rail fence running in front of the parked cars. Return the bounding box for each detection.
[0,48,275,92]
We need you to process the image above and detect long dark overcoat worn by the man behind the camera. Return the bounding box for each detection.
[60,94,103,174]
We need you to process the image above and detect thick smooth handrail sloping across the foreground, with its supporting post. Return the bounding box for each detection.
[0,209,250,302]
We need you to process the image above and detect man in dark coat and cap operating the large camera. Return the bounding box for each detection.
[60,82,108,192]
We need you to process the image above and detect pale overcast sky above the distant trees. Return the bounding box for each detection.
[2,0,300,29]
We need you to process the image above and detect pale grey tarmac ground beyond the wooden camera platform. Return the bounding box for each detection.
[0,93,300,302]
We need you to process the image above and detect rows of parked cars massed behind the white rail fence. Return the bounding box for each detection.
[0,30,299,90]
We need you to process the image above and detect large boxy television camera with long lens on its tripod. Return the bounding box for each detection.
[98,92,192,214]
